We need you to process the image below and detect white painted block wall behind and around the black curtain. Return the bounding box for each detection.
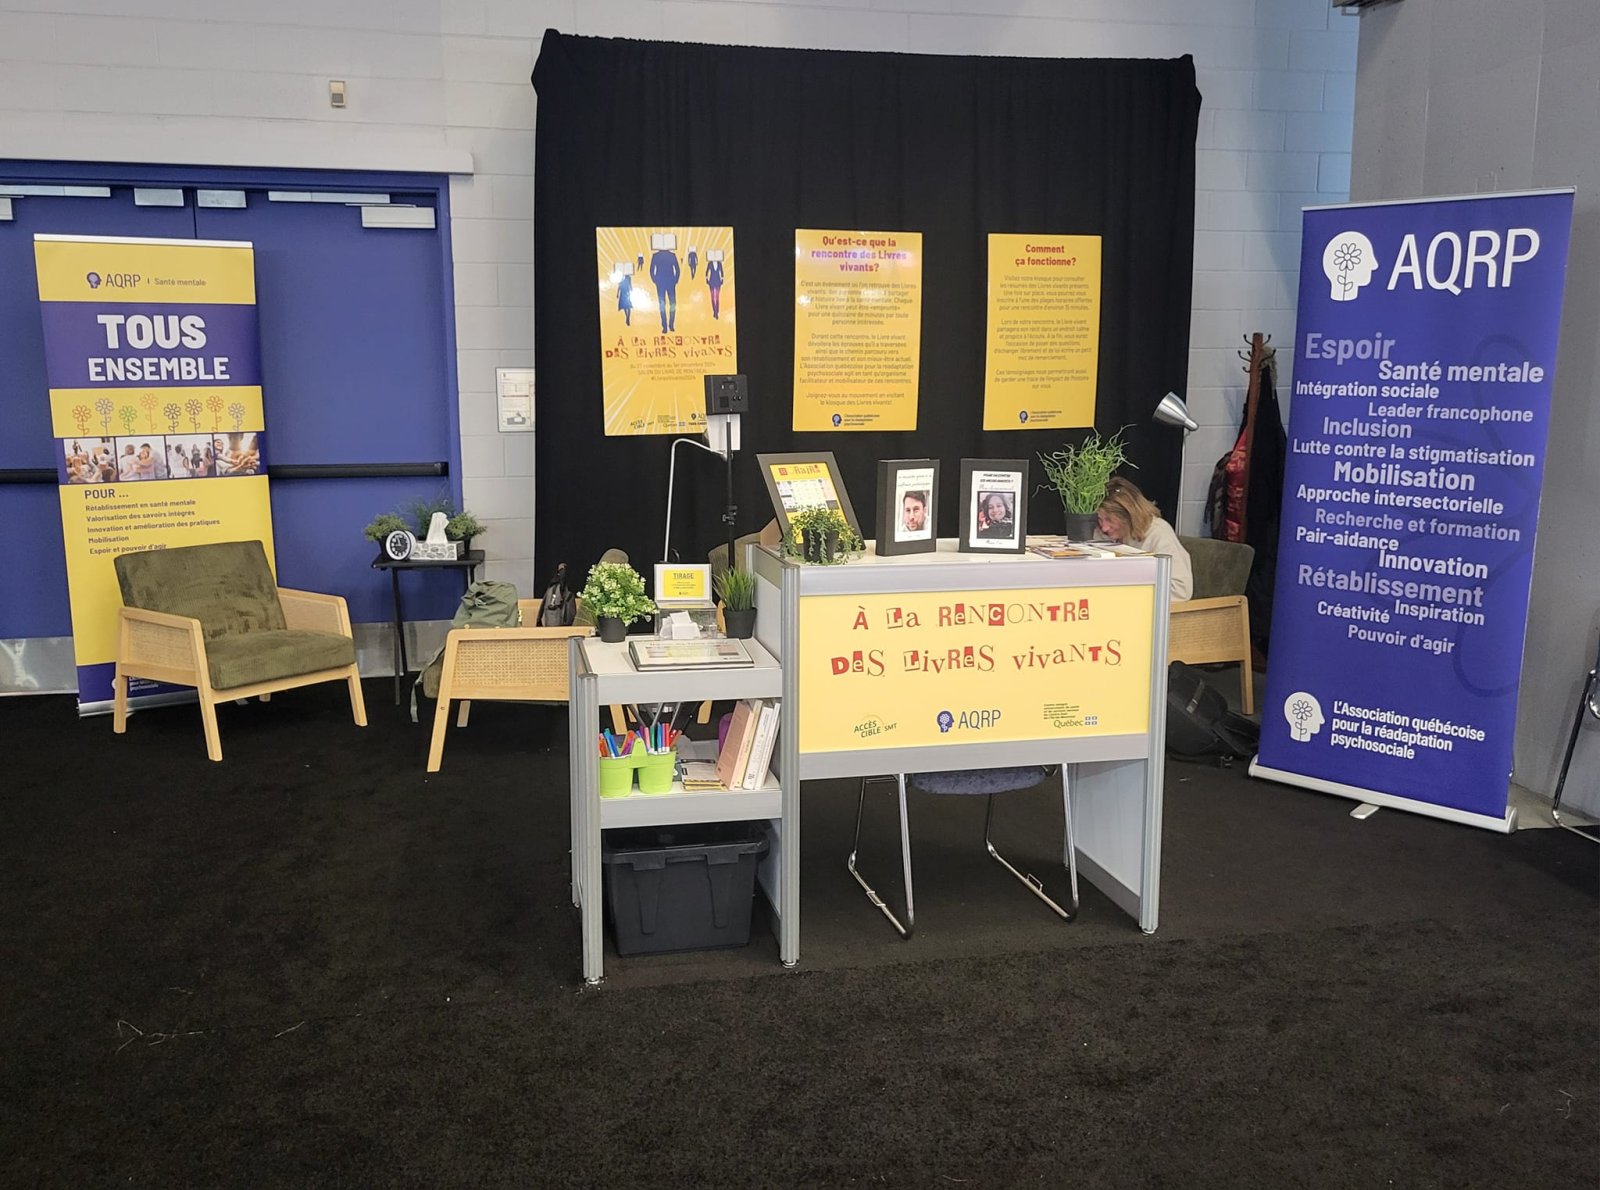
[0,0,1357,592]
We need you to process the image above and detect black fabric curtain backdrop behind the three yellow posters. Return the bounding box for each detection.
[533,29,1200,582]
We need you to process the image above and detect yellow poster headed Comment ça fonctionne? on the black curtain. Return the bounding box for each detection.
[984,235,1101,430]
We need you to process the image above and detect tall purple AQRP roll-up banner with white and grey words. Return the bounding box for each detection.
[1251,190,1573,830]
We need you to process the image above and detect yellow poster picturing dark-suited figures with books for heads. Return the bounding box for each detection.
[595,227,739,437]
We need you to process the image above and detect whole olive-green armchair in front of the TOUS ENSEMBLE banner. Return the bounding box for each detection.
[112,541,366,760]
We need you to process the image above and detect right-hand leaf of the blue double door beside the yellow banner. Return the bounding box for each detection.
[195,195,461,622]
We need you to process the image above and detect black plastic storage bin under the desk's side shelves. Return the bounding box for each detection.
[600,822,768,955]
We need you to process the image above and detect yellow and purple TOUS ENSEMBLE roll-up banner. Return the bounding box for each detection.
[34,235,272,712]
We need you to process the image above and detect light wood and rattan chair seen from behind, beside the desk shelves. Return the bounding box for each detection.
[427,600,594,773]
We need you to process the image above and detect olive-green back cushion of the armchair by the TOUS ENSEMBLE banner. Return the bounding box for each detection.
[112,541,288,642]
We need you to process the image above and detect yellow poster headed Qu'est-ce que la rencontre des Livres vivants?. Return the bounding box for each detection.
[794,230,922,430]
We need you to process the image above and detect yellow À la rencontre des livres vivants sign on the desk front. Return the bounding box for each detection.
[797,585,1154,753]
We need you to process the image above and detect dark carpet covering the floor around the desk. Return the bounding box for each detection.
[0,681,1600,1187]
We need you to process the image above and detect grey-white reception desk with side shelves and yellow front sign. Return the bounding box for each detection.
[571,541,1168,982]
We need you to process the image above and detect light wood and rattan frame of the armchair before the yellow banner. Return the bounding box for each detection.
[112,587,366,760]
